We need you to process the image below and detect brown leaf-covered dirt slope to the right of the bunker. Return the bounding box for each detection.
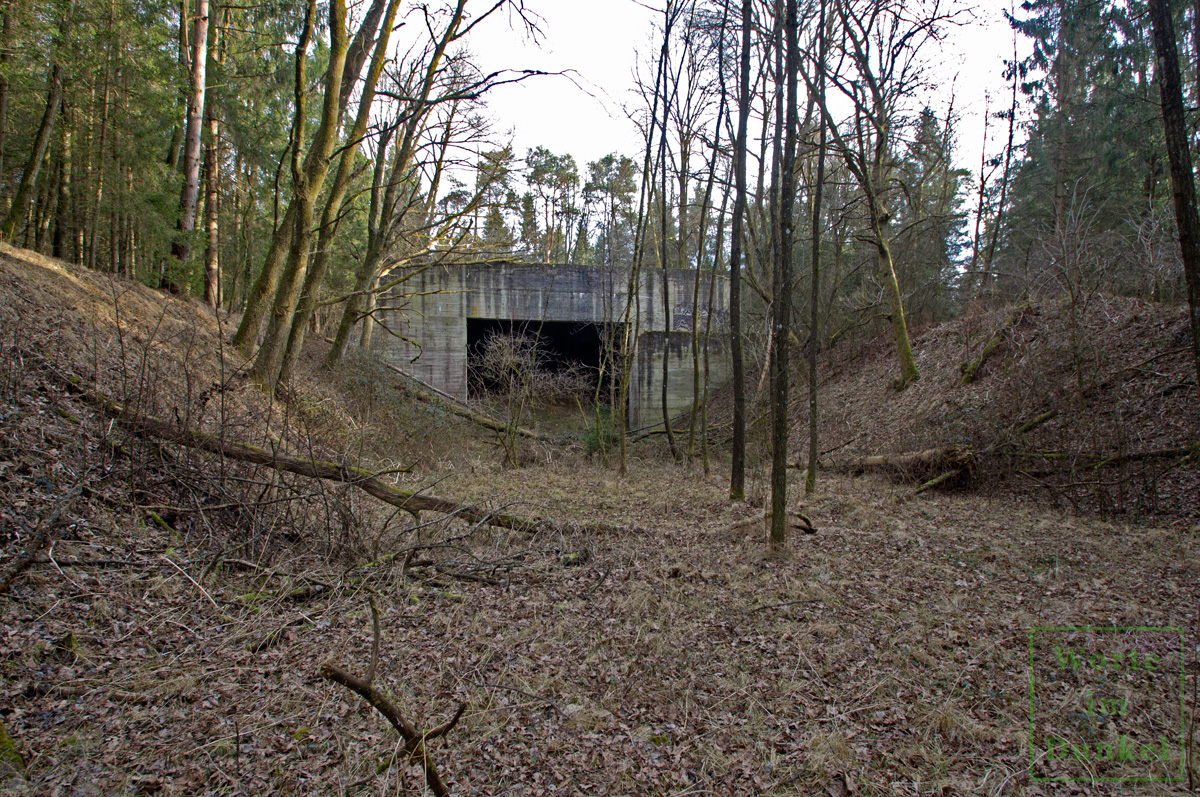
[793,296,1200,522]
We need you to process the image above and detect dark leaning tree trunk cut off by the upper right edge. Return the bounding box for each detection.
[1150,0,1200,380]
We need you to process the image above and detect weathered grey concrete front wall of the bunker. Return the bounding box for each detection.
[380,263,730,429]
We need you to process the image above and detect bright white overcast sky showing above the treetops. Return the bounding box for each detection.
[469,0,1027,187]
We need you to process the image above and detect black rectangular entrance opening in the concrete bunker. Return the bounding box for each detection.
[467,318,623,407]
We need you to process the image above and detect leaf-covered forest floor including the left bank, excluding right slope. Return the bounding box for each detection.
[0,248,1200,797]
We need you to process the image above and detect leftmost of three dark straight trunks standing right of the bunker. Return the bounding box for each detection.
[730,0,754,501]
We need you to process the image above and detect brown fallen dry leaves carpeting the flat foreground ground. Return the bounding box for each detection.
[0,451,1200,795]
